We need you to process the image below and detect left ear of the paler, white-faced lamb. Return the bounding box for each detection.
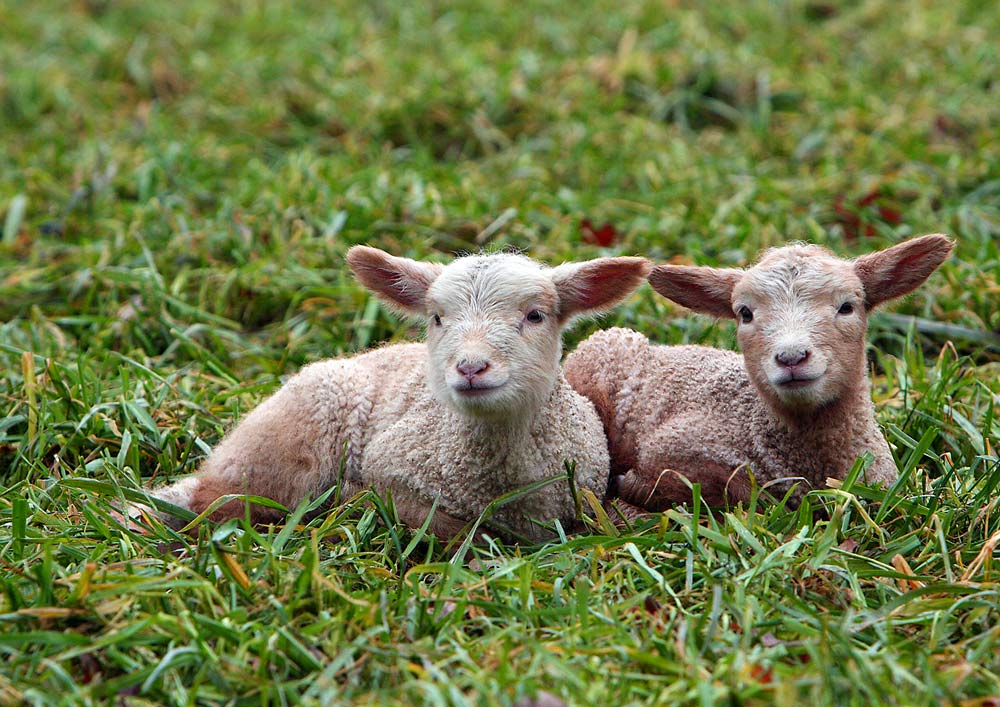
[347,245,444,316]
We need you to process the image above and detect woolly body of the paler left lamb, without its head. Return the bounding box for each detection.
[154,343,609,539]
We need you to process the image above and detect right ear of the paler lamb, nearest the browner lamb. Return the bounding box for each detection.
[552,257,650,324]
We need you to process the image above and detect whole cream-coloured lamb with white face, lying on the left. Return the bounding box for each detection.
[145,246,649,540]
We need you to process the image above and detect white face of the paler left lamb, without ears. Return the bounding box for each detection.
[425,255,562,420]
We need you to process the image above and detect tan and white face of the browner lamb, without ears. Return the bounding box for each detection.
[732,248,867,410]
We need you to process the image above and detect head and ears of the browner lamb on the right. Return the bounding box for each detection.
[649,234,952,416]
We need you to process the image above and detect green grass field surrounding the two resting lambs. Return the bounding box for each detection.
[0,0,1000,707]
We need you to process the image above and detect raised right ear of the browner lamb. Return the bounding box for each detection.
[854,233,955,309]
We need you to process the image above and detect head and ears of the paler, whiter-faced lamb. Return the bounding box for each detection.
[347,246,649,420]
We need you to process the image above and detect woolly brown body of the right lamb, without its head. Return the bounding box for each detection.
[564,328,897,510]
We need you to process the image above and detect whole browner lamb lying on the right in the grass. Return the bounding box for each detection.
[564,235,953,515]
